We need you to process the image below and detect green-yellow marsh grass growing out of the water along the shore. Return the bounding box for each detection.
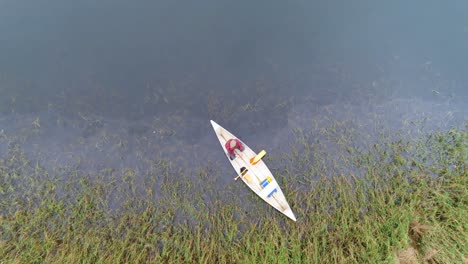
[0,115,468,263]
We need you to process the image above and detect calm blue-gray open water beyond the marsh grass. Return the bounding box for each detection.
[0,0,468,186]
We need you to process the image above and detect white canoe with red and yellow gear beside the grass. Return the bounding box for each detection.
[211,120,296,221]
